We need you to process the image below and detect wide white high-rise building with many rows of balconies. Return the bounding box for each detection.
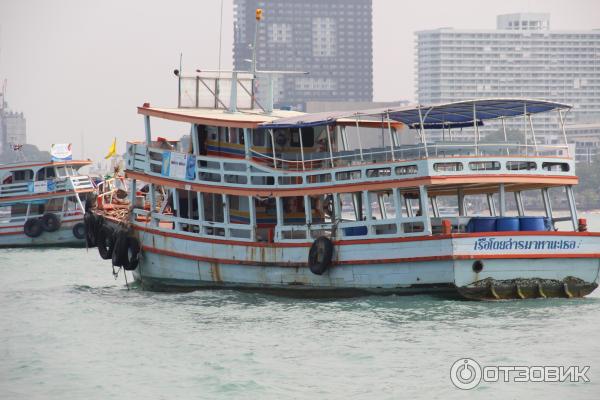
[416,13,600,144]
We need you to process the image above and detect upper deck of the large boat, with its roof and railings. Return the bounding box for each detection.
[126,99,577,196]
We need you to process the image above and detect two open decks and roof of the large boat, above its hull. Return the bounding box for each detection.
[126,74,578,243]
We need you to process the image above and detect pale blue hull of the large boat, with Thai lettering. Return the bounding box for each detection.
[123,223,600,300]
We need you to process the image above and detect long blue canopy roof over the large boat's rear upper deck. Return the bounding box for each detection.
[260,98,571,129]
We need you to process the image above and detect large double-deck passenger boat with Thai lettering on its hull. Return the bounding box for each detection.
[87,73,600,299]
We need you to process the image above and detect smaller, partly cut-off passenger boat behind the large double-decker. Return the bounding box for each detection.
[0,160,94,247]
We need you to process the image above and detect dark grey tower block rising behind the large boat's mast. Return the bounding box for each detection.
[233,0,373,110]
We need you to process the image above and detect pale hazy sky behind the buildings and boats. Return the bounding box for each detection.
[0,0,600,159]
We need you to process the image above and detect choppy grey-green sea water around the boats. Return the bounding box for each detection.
[0,216,600,399]
